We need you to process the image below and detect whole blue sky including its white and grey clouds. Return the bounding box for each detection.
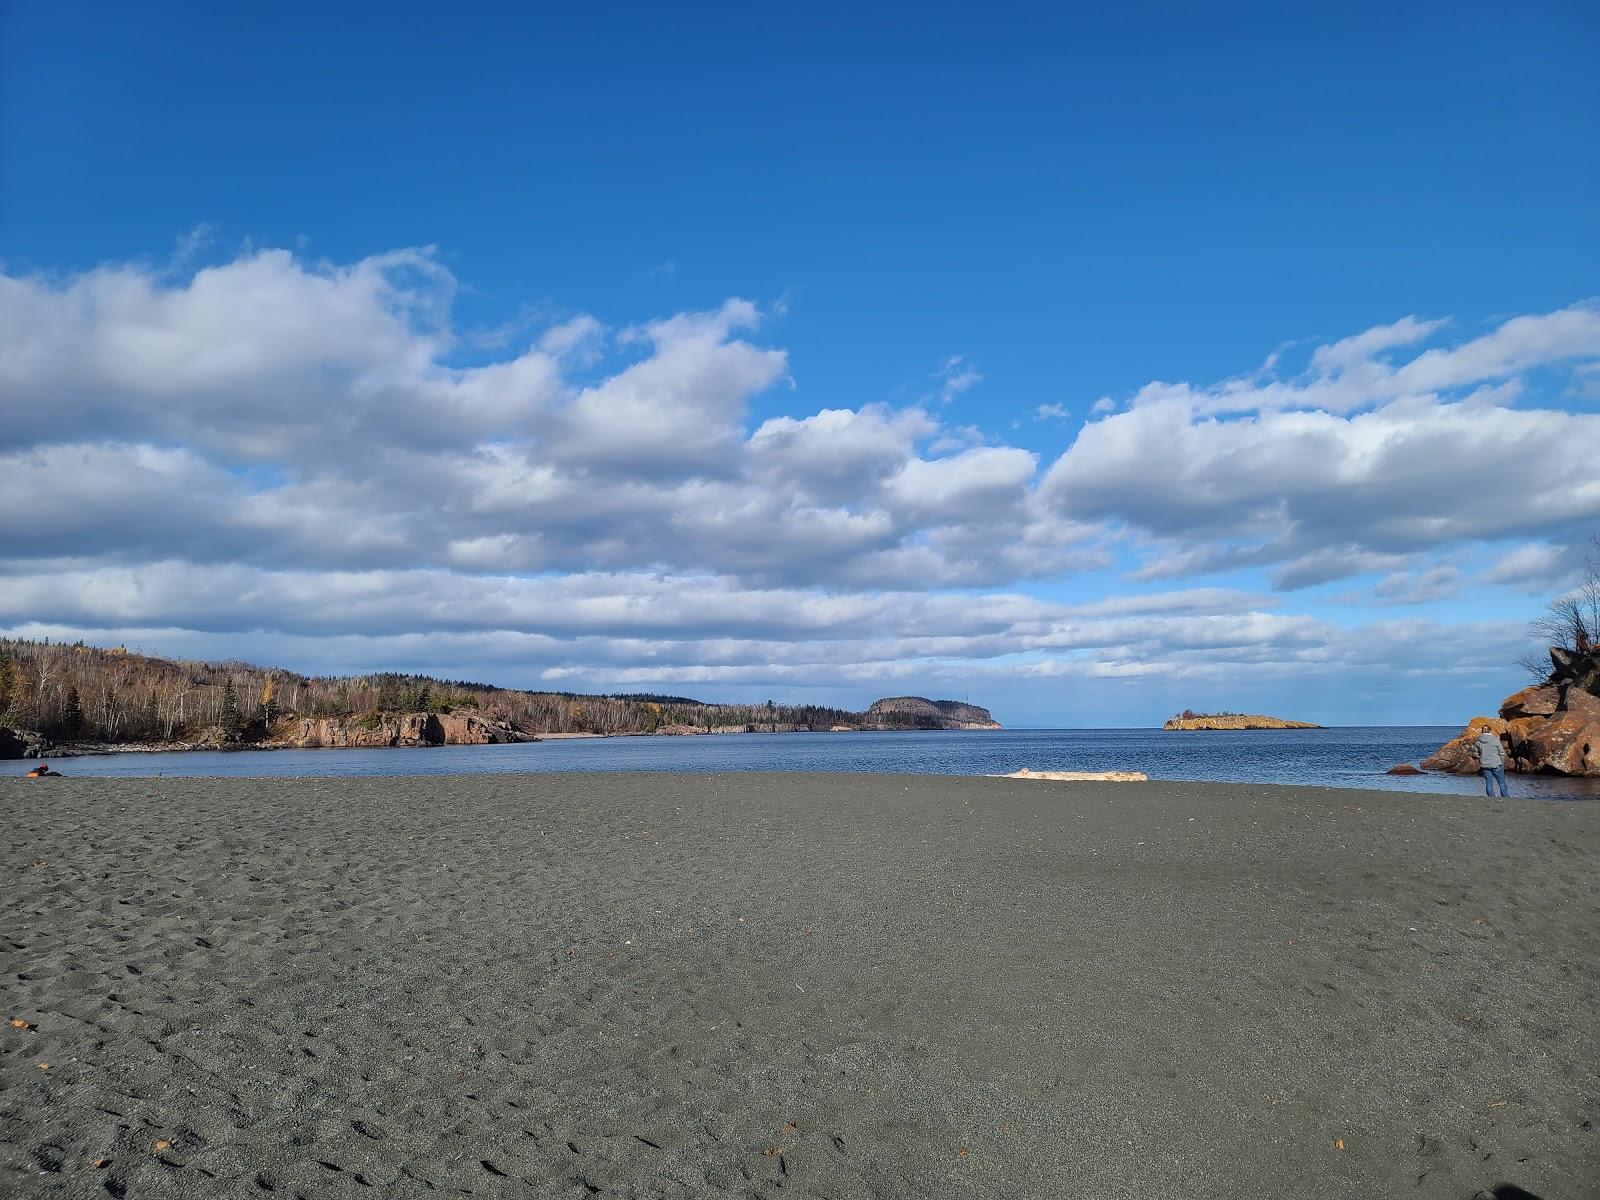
[0,2,1600,725]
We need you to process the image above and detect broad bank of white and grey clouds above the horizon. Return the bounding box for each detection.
[0,240,1600,720]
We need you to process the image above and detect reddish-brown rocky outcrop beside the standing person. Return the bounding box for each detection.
[1422,650,1600,776]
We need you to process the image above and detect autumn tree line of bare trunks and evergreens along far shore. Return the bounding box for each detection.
[0,638,862,742]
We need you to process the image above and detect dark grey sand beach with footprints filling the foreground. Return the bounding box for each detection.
[0,774,1600,1200]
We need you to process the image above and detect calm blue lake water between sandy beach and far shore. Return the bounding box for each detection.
[43,726,1600,800]
